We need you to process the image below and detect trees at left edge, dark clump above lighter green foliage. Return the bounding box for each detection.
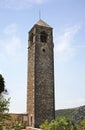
[0,74,10,130]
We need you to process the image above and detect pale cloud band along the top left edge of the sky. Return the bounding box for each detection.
[0,0,47,9]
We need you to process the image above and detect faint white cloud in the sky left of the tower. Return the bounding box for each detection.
[0,24,21,56]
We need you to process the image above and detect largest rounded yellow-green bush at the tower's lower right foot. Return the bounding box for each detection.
[40,117,77,130]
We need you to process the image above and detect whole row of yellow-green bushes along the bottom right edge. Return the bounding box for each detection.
[40,117,85,130]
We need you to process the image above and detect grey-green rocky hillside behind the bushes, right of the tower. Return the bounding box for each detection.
[55,106,85,123]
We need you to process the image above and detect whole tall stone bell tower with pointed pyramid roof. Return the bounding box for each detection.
[27,19,55,127]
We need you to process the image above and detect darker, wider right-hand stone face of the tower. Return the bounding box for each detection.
[35,27,55,127]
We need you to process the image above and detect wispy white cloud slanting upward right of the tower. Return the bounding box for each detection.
[54,26,80,61]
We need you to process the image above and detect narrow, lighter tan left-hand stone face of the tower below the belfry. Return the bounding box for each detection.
[27,38,35,126]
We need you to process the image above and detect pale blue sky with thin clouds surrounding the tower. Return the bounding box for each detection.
[0,0,85,113]
